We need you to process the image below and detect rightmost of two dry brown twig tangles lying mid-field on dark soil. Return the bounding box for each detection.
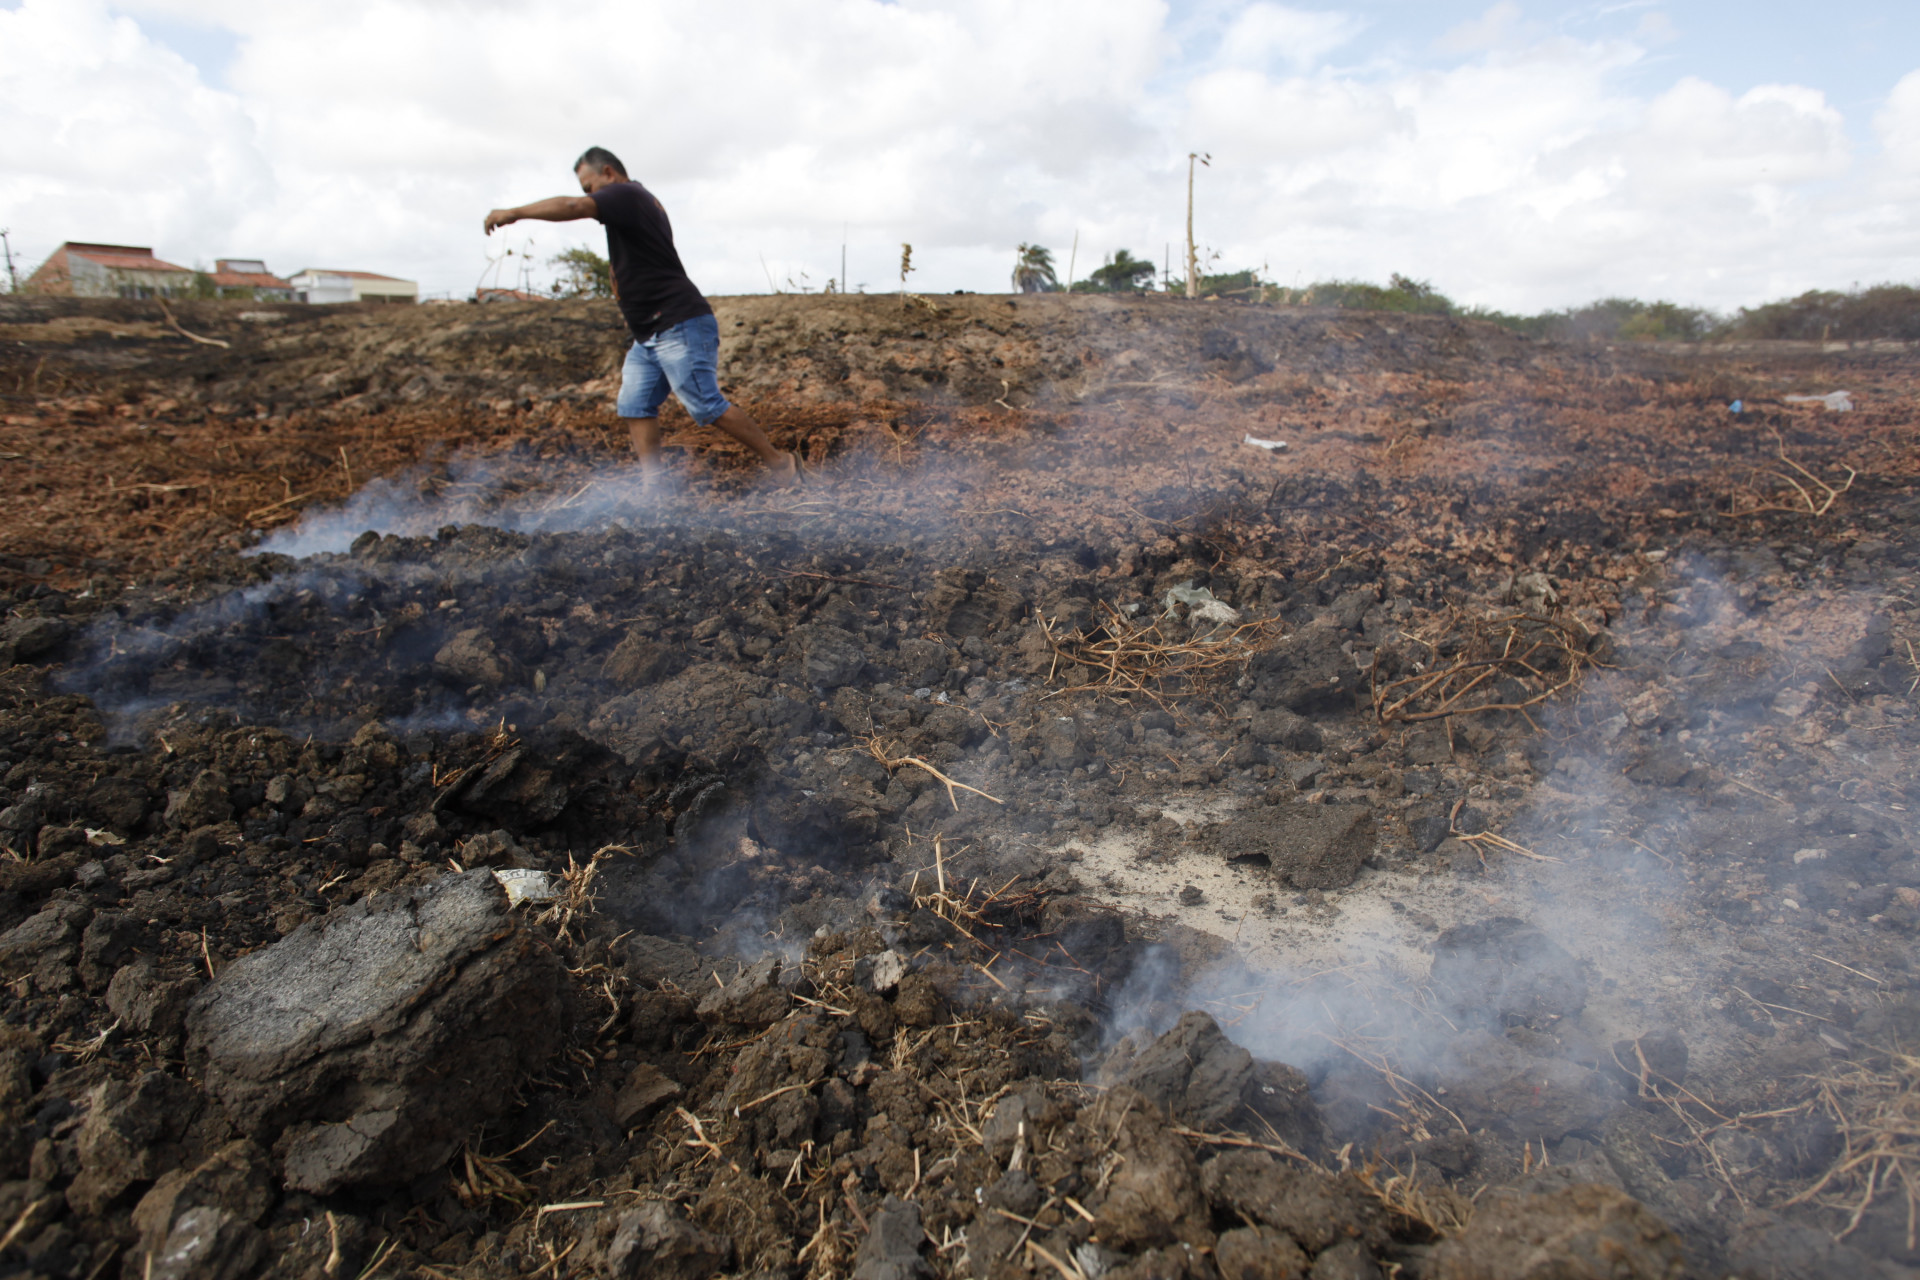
[1371,610,1601,723]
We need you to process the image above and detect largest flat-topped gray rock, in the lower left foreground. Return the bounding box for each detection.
[186,869,564,1194]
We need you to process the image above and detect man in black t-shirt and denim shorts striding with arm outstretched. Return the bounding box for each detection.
[486,146,801,482]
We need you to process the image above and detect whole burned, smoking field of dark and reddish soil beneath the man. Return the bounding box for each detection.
[0,297,1920,1276]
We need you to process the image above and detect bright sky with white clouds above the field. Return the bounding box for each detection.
[0,0,1920,311]
